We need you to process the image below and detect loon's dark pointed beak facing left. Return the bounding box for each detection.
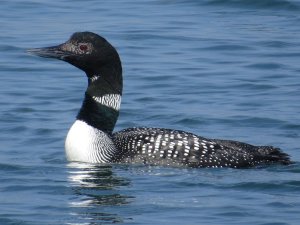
[27,45,71,60]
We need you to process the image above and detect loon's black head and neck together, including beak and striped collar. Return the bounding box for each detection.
[28,32,123,133]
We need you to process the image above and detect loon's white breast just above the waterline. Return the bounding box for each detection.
[65,120,116,163]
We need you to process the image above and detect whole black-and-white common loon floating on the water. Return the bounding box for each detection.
[28,32,290,168]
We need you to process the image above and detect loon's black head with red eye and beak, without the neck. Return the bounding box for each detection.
[28,32,122,83]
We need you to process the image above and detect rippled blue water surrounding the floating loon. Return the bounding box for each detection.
[0,0,300,225]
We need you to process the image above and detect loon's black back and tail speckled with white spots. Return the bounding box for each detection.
[112,128,288,168]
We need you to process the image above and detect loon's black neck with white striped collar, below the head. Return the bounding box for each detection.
[77,67,122,134]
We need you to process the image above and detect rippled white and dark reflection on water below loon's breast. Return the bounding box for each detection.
[68,163,133,225]
